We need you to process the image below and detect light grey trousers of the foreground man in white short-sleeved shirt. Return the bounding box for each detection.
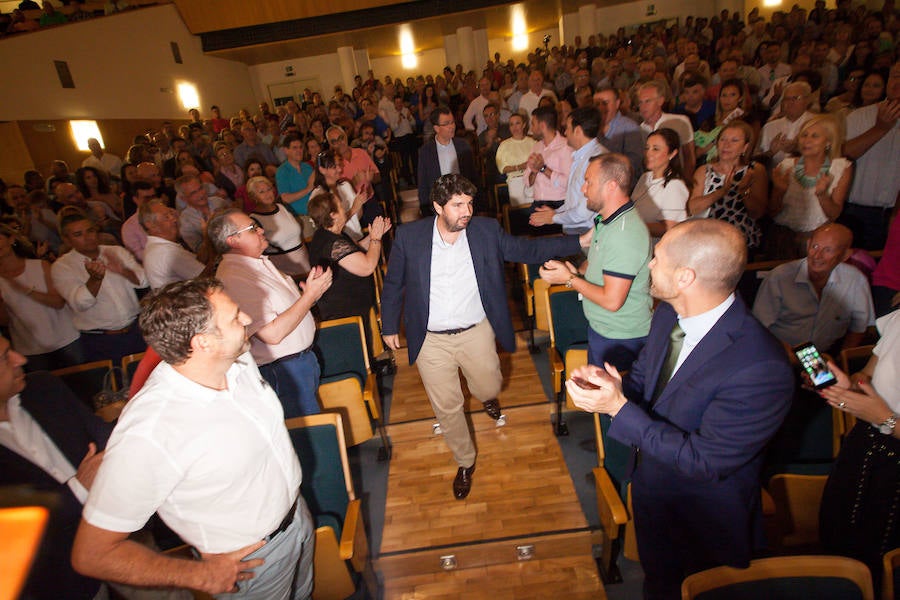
[216,496,316,600]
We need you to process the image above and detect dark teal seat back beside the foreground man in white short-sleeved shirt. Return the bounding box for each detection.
[284,413,356,539]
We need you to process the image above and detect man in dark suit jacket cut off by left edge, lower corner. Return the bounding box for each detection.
[0,338,112,600]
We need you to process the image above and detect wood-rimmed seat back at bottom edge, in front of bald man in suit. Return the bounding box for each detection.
[681,556,874,600]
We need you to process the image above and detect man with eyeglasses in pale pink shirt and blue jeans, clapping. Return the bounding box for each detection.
[207,208,332,419]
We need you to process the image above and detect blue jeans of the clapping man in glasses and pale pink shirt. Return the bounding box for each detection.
[259,352,321,419]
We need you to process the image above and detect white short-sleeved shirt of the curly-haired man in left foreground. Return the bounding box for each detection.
[83,353,301,553]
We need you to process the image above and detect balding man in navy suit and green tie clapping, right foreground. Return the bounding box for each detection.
[566,219,794,599]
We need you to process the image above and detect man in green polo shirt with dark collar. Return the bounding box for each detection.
[541,154,652,371]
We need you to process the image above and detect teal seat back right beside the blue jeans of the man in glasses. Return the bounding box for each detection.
[316,317,369,385]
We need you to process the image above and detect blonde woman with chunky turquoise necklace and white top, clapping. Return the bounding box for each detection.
[767,114,853,259]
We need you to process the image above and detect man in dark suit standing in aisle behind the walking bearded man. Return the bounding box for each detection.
[418,106,478,217]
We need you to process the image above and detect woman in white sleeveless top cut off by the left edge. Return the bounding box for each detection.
[0,224,84,371]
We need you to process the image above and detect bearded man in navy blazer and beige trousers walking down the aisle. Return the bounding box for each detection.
[382,174,580,500]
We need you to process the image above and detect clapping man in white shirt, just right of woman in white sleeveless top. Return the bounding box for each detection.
[50,209,147,362]
